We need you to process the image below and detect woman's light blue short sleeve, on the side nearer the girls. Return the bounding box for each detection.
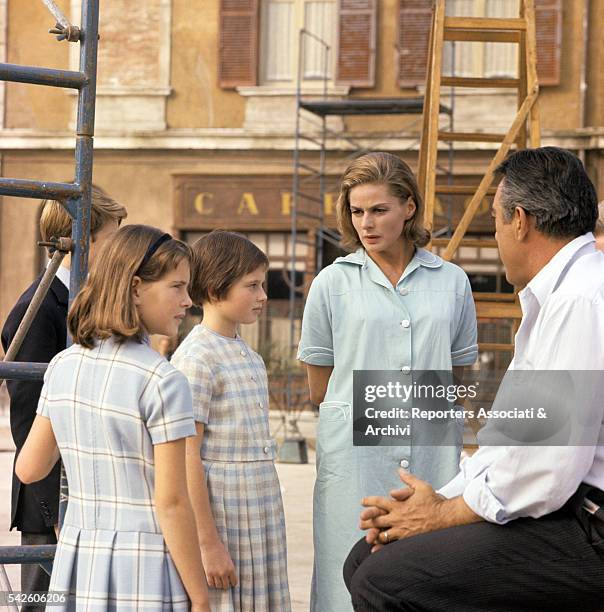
[298,268,334,366]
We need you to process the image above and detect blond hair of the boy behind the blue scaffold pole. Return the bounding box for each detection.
[40,185,128,257]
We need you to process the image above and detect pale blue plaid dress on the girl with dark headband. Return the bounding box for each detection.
[38,339,195,612]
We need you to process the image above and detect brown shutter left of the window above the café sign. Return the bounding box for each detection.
[218,0,259,88]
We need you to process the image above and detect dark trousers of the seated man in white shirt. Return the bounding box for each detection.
[344,508,604,612]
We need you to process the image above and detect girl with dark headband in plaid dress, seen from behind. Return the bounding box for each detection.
[16,225,210,612]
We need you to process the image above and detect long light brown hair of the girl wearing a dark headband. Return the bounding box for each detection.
[67,225,191,348]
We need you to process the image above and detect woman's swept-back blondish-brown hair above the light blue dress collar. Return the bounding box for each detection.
[336,152,430,250]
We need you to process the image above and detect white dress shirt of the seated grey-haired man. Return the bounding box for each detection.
[439,232,604,524]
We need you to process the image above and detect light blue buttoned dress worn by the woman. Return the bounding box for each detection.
[298,248,478,612]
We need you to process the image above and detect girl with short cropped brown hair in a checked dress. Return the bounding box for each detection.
[172,231,290,612]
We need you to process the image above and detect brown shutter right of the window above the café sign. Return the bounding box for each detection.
[337,0,377,87]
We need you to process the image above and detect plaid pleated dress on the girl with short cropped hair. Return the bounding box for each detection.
[172,325,291,612]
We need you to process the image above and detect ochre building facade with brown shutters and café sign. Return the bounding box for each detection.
[0,0,604,368]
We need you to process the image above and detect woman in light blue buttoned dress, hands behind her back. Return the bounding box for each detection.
[298,153,478,612]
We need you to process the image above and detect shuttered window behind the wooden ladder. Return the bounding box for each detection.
[398,0,562,87]
